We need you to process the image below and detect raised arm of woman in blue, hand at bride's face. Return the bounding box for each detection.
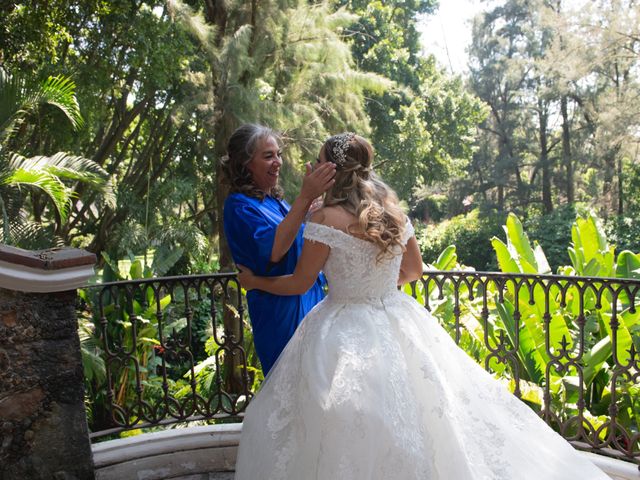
[270,162,336,263]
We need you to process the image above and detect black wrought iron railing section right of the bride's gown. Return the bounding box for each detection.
[412,272,640,463]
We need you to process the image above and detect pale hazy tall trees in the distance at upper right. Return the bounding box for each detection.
[456,0,640,218]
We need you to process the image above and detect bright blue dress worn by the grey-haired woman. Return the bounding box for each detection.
[224,193,324,375]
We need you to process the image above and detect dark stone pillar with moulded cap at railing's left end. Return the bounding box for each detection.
[0,245,96,480]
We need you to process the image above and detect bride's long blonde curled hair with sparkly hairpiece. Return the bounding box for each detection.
[322,134,406,262]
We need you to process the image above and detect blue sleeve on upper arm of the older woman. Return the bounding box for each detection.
[224,200,277,275]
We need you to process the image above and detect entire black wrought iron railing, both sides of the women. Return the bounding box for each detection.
[84,271,640,463]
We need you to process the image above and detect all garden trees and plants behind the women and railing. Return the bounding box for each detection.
[0,0,640,442]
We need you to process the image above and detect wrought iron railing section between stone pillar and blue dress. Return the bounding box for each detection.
[83,273,252,438]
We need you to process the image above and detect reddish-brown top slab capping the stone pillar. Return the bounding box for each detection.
[0,245,96,270]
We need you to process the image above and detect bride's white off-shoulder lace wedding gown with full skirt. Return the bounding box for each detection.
[236,223,609,480]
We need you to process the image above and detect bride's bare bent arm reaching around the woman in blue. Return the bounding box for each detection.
[238,239,331,295]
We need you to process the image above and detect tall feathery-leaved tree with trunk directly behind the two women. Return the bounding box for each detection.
[170,0,389,391]
